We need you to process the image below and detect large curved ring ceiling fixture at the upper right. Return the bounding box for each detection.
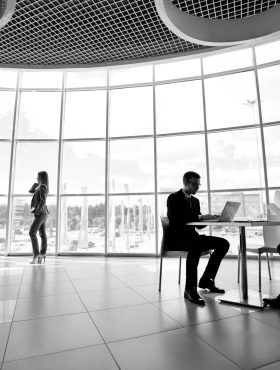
[155,0,280,47]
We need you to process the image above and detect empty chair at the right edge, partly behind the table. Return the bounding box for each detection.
[237,215,280,292]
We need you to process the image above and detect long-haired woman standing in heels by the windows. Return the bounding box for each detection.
[29,171,49,264]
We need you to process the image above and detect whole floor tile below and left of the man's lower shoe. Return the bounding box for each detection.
[90,304,181,342]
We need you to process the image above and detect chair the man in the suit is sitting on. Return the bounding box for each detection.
[158,216,211,292]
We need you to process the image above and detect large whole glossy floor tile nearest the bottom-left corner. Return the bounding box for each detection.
[4,313,103,361]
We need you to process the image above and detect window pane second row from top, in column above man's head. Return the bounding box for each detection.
[156,80,204,134]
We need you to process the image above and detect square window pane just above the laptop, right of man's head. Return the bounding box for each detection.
[208,128,264,189]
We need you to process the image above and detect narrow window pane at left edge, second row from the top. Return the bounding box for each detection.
[0,91,16,139]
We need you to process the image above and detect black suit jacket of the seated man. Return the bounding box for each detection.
[167,189,201,250]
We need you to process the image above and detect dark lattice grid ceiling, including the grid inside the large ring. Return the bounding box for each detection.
[0,0,280,68]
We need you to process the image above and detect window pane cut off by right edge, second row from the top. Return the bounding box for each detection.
[258,65,280,123]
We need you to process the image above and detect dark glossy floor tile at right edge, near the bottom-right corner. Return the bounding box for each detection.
[186,315,280,369]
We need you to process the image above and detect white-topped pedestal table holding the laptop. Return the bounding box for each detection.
[187,221,280,308]
